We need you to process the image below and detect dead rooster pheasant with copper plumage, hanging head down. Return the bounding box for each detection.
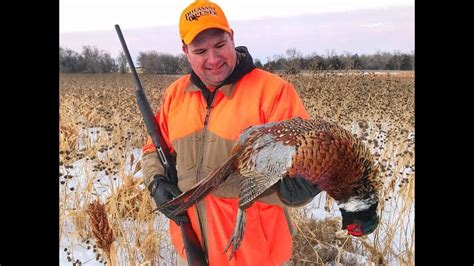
[162,117,381,259]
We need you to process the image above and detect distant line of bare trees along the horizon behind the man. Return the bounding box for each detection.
[59,46,415,74]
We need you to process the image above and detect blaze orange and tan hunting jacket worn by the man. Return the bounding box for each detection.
[143,69,309,266]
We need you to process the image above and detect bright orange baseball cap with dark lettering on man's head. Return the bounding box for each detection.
[179,0,231,45]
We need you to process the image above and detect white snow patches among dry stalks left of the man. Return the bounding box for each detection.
[59,128,166,265]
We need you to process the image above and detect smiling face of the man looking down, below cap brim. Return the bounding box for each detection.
[183,29,237,86]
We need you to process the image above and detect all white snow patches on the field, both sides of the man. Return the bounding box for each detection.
[59,124,414,265]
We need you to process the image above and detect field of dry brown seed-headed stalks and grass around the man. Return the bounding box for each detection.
[59,72,415,265]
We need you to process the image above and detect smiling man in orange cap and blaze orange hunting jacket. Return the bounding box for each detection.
[142,1,316,266]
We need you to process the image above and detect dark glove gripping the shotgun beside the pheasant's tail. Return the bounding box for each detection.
[148,175,189,225]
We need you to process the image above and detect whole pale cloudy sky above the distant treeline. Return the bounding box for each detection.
[59,0,415,63]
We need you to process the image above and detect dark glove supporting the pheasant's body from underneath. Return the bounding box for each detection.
[278,177,321,206]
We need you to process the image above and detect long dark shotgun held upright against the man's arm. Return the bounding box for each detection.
[115,25,208,266]
